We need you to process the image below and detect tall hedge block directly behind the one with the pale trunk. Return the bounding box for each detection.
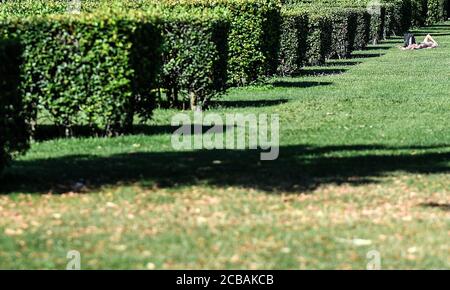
[152,0,281,85]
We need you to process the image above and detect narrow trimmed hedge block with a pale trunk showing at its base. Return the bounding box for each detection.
[160,9,228,109]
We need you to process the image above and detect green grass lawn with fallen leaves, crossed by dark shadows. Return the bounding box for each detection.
[0,23,450,269]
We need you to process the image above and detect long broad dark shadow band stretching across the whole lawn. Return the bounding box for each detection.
[0,145,450,194]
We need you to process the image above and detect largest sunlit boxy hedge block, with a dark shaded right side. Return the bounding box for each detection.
[0,12,161,134]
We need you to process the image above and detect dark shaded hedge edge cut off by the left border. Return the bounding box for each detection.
[0,40,29,173]
